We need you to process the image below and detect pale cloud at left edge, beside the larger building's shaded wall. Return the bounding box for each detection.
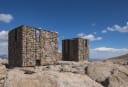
[0,31,8,55]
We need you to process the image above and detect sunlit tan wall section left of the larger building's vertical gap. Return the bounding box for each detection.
[22,26,35,66]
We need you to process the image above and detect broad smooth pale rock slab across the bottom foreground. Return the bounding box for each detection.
[4,70,103,87]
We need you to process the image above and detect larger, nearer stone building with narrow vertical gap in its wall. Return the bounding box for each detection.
[8,26,59,66]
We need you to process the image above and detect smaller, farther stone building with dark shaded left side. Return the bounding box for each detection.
[62,38,89,61]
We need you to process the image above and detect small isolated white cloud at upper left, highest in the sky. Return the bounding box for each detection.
[0,13,13,23]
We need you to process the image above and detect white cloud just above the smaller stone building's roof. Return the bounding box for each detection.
[77,33,102,41]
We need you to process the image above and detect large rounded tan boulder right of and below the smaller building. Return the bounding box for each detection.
[87,62,113,82]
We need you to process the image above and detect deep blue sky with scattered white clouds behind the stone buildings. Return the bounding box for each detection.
[0,0,128,59]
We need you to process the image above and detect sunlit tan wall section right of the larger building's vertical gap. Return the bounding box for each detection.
[40,31,58,64]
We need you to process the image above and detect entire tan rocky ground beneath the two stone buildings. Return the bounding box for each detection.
[0,55,128,87]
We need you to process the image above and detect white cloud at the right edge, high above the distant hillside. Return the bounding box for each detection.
[107,22,128,32]
